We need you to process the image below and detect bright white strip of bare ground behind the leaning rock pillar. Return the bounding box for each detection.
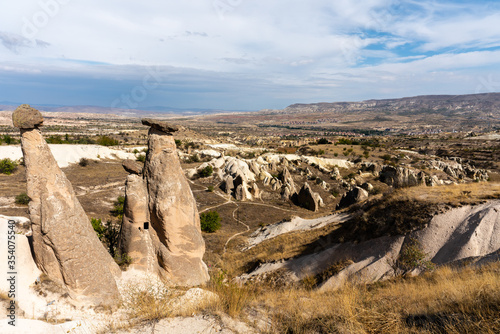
[0,144,136,168]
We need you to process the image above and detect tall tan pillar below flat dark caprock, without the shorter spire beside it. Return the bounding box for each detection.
[144,126,209,286]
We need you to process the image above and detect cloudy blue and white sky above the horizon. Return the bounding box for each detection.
[0,0,500,110]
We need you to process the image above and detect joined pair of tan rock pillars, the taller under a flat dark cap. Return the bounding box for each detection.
[120,119,209,286]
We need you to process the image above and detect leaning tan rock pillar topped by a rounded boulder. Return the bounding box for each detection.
[12,105,121,305]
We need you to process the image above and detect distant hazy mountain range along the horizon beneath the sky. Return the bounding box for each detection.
[0,93,500,118]
